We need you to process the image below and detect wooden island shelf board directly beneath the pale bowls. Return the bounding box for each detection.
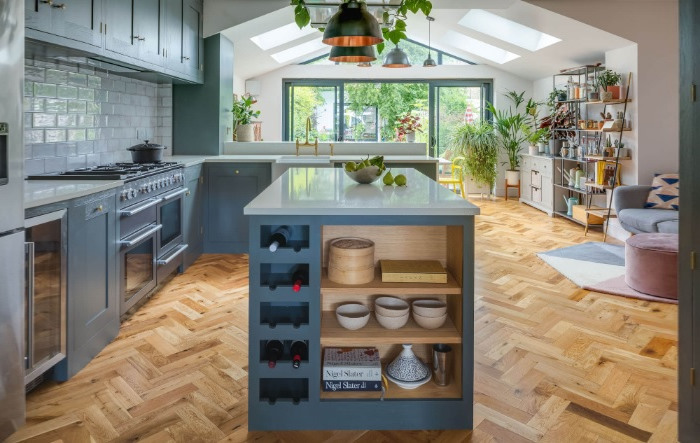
[321,311,462,347]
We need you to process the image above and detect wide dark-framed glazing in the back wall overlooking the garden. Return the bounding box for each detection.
[283,80,492,156]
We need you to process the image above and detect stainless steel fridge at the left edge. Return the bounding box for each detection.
[0,0,25,441]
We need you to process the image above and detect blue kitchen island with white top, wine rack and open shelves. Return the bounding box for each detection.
[244,168,479,430]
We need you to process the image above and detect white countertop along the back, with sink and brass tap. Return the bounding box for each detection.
[163,152,438,167]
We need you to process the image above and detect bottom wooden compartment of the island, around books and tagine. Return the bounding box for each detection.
[321,344,462,401]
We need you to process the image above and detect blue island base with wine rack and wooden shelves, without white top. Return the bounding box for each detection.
[248,215,474,430]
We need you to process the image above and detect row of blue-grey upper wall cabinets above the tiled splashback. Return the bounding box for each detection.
[25,0,203,83]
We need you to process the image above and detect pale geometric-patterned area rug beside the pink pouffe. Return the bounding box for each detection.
[537,242,678,304]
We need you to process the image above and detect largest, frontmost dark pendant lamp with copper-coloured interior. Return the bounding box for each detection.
[323,0,384,46]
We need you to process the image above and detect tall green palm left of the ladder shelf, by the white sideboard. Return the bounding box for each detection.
[486,91,527,171]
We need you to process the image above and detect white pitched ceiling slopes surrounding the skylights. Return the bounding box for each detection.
[220,0,633,80]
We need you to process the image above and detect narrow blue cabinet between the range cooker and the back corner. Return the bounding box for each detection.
[183,164,206,271]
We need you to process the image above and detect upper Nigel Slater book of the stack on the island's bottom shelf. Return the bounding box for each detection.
[322,348,382,384]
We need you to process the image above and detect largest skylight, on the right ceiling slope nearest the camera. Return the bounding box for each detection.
[459,9,561,51]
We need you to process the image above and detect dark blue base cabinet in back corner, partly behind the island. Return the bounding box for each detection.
[204,163,271,254]
